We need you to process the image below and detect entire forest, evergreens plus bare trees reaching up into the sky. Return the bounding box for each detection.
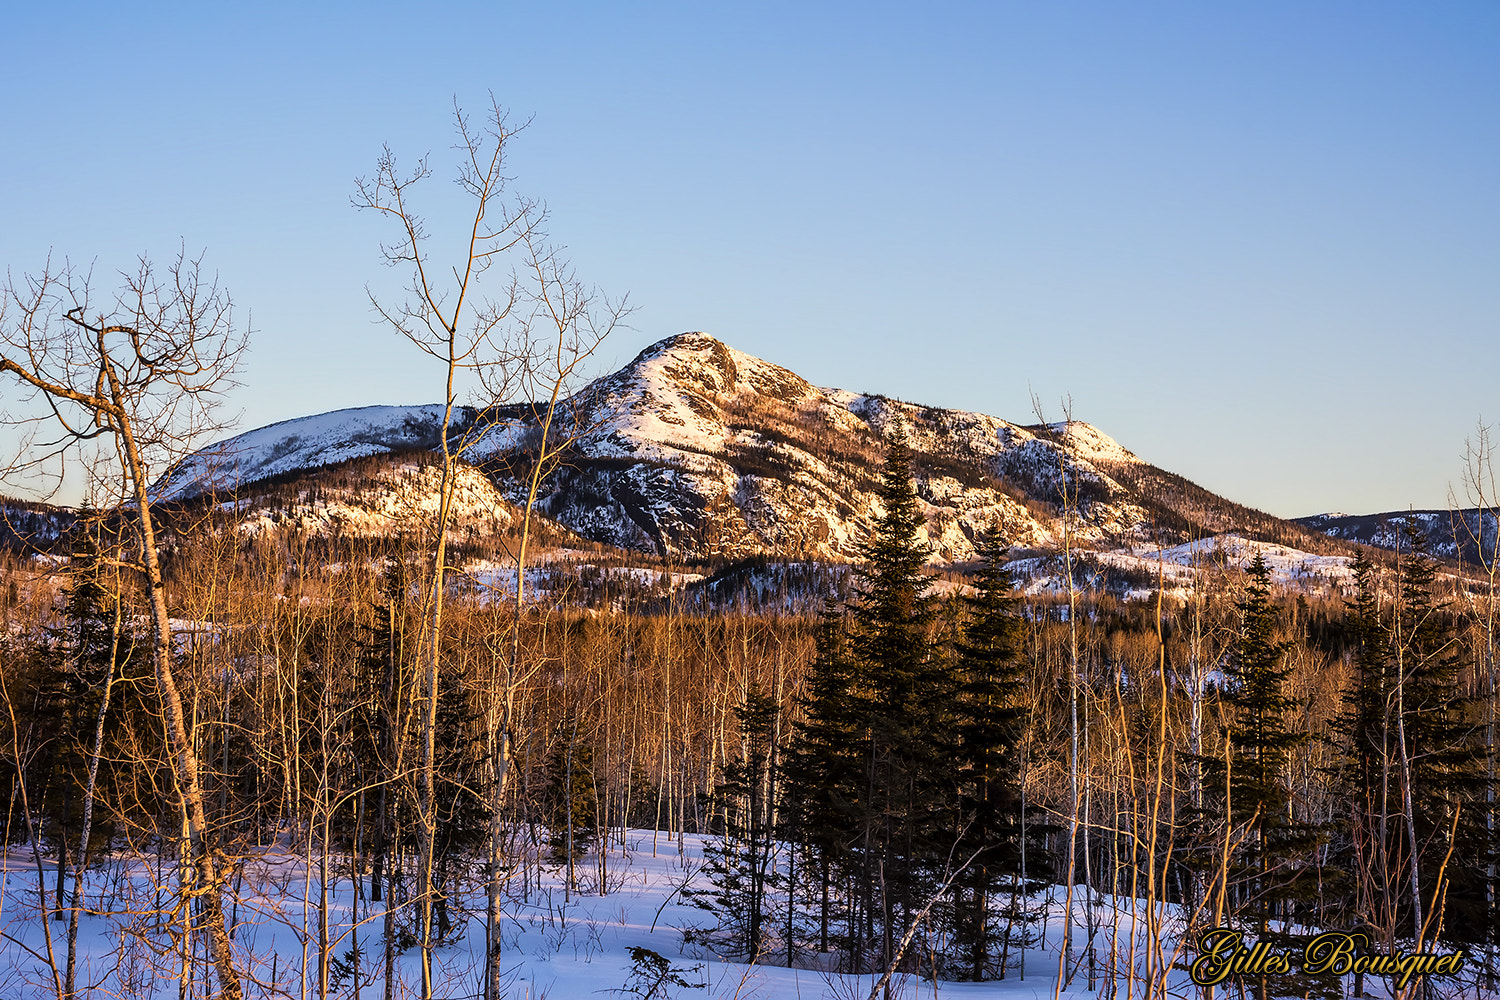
[0,109,1497,1000]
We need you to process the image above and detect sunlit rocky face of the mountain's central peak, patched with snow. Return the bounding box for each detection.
[468,333,1145,562]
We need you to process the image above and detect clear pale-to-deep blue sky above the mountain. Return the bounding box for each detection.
[0,0,1500,516]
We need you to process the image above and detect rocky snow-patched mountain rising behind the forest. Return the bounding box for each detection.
[158,333,1335,564]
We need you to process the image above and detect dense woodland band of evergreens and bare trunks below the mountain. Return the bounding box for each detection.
[0,439,1496,997]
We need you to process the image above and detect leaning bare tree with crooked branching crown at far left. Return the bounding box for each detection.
[0,252,245,1000]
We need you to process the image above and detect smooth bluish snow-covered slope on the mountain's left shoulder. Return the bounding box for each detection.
[155,403,474,501]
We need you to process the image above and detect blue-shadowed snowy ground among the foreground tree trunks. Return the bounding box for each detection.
[0,831,1218,1000]
